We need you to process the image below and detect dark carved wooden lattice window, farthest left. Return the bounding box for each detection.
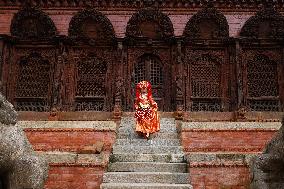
[15,54,50,112]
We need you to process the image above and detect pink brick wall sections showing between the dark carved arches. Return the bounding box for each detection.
[0,9,254,38]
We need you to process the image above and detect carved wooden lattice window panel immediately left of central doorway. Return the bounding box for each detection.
[70,47,115,111]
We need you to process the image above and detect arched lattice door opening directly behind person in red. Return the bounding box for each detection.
[135,55,163,107]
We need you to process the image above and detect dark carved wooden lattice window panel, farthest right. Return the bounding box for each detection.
[243,50,281,111]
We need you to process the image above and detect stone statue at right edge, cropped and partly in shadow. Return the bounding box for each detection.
[250,117,284,189]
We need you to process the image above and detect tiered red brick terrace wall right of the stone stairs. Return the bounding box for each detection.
[181,122,281,189]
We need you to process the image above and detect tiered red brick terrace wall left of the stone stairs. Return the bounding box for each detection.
[17,121,116,189]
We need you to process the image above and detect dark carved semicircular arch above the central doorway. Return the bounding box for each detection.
[126,9,174,39]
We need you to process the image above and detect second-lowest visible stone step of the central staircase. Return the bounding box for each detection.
[103,172,189,184]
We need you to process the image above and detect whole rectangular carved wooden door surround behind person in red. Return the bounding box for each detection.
[124,48,174,111]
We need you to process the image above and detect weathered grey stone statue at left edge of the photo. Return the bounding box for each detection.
[0,93,48,189]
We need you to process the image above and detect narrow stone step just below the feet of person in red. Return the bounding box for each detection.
[115,138,180,146]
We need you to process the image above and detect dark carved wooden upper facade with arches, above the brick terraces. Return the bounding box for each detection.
[0,1,284,112]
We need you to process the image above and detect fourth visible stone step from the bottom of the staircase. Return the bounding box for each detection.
[110,153,186,163]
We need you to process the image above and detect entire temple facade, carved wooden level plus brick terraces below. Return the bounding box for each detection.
[0,0,284,189]
